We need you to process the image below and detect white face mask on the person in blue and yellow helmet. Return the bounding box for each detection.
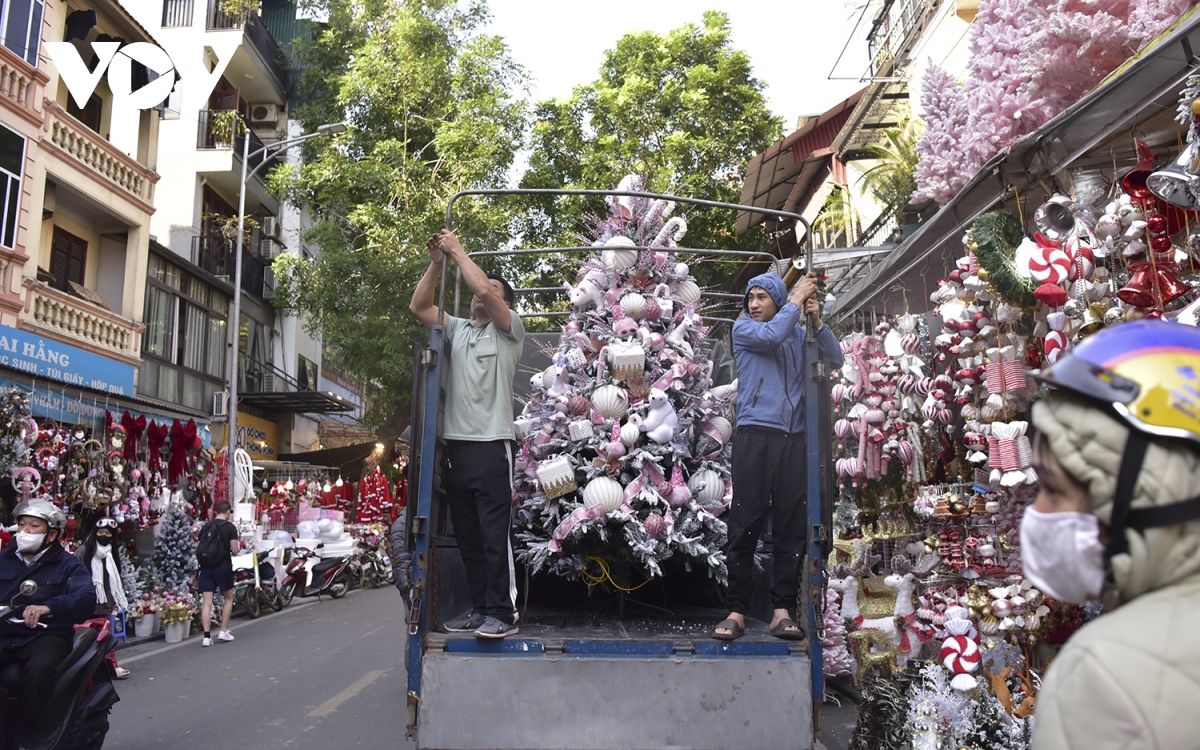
[1021,508,1104,604]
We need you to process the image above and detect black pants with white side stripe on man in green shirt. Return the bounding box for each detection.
[442,440,517,623]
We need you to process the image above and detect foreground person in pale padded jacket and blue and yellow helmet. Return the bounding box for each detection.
[1020,320,1200,750]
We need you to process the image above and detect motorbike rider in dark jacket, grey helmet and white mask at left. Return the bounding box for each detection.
[0,498,96,746]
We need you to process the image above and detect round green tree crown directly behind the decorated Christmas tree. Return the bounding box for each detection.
[515,11,782,292]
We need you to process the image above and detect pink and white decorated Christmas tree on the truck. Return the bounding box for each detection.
[515,178,733,586]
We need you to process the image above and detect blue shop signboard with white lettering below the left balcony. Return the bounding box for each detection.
[0,325,134,396]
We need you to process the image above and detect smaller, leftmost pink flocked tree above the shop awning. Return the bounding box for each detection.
[913,65,971,204]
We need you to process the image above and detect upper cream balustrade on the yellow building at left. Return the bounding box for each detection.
[43,101,158,211]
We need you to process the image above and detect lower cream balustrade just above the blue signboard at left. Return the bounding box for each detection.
[23,278,143,365]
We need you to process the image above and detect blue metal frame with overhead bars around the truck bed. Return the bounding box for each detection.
[407,190,832,746]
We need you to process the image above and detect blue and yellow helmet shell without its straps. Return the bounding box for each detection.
[1037,320,1200,443]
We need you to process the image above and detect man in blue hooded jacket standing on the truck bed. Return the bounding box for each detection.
[713,274,844,641]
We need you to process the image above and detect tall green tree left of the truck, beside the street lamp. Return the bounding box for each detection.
[271,0,527,444]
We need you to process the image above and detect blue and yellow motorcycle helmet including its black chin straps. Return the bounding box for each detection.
[1034,320,1200,559]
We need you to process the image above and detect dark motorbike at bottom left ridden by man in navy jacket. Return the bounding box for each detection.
[0,581,120,750]
